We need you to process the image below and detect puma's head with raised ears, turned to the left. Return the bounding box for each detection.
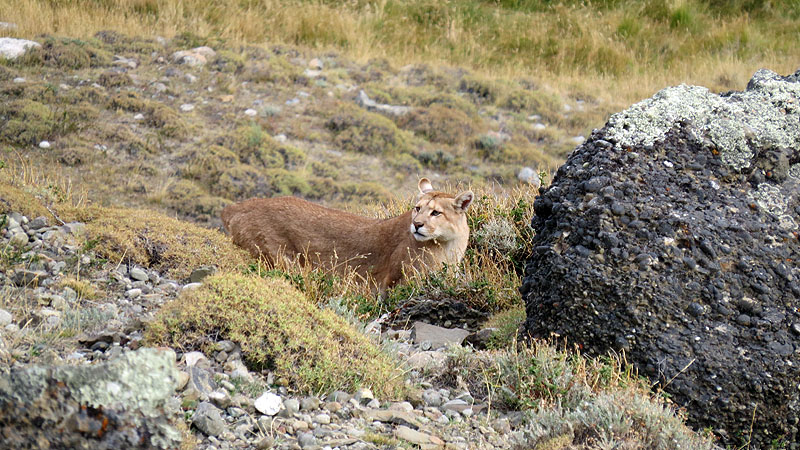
[409,178,474,243]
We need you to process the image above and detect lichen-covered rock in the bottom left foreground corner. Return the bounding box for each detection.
[0,348,181,449]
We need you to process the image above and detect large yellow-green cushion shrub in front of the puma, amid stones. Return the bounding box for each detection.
[146,273,405,400]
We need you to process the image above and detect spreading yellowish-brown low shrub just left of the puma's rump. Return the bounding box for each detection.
[57,206,249,278]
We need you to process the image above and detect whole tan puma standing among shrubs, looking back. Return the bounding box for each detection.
[222,178,473,290]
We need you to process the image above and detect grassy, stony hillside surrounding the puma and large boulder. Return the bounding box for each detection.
[0,0,800,449]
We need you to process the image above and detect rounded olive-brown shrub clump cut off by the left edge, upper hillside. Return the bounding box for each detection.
[0,100,57,145]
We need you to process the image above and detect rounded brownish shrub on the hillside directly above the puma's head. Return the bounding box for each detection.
[398,104,475,145]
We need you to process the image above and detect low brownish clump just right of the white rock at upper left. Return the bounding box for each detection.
[17,37,112,70]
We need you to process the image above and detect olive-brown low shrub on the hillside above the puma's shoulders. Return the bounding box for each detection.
[326,105,410,155]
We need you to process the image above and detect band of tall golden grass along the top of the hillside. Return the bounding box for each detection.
[0,0,800,110]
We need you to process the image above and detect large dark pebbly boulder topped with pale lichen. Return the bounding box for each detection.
[521,70,800,449]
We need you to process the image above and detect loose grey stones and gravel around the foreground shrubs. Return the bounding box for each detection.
[0,209,521,449]
